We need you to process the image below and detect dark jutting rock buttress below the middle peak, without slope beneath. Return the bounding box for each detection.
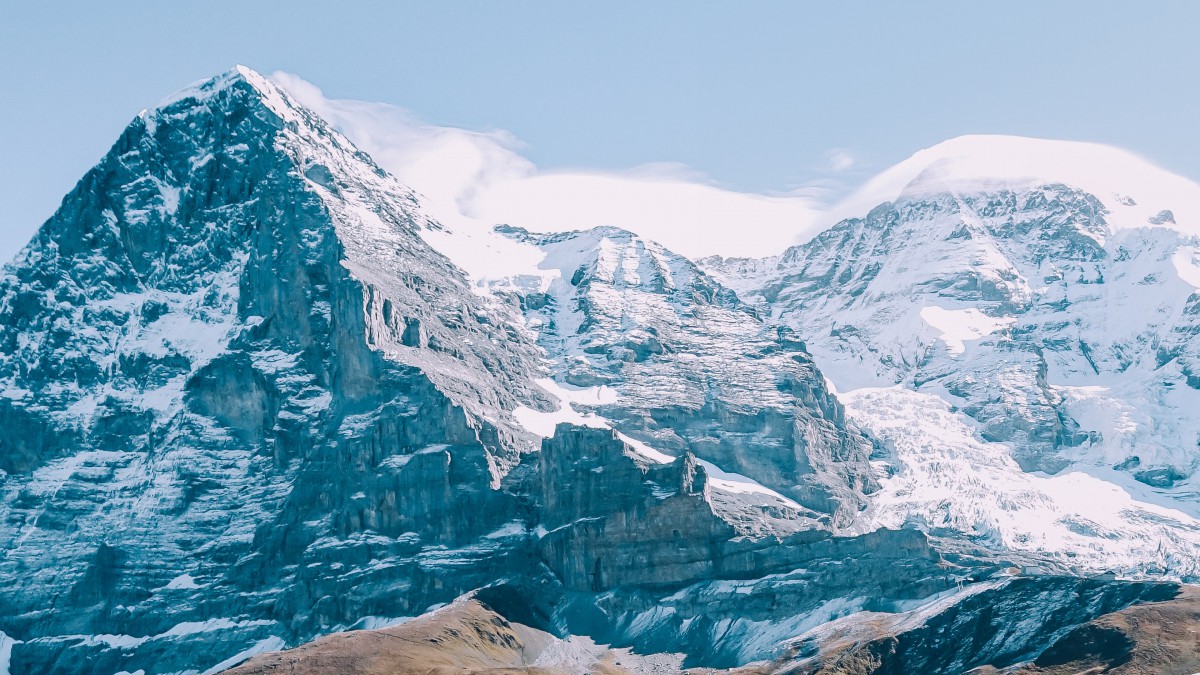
[536,426,938,592]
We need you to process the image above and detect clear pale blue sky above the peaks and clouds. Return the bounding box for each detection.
[0,0,1200,258]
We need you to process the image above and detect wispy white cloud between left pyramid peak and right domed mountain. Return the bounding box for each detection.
[272,72,830,257]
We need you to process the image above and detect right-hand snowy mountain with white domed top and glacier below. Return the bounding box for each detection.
[707,137,1200,575]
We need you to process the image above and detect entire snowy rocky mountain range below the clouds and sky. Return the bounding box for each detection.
[0,67,1200,675]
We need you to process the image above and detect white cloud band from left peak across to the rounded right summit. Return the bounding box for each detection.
[272,73,1200,261]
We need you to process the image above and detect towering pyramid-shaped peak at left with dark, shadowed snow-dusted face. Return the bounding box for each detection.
[0,66,548,673]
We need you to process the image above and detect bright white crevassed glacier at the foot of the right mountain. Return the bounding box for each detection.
[841,387,1200,578]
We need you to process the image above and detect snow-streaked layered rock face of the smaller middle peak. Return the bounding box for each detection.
[504,228,877,527]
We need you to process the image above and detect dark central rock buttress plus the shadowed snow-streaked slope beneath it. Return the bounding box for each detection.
[508,425,961,668]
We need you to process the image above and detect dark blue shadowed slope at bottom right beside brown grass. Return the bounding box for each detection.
[792,577,1196,675]
